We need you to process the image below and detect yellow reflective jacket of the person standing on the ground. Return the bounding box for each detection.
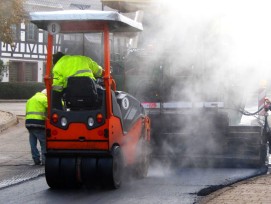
[25,92,48,128]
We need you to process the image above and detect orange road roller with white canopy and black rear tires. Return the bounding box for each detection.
[30,10,151,189]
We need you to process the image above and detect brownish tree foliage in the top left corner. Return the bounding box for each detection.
[0,0,27,44]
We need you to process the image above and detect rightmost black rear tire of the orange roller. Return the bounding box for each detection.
[98,146,123,189]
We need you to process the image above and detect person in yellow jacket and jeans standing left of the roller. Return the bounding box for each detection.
[25,89,48,165]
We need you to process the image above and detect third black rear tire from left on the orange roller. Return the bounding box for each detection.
[81,157,98,188]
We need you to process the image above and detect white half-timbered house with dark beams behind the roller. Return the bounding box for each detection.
[0,0,132,82]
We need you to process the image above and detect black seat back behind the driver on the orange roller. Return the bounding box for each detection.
[63,77,98,110]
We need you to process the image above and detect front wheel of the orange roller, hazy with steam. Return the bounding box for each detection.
[134,138,150,179]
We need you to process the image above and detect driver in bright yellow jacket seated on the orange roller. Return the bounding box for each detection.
[52,52,103,109]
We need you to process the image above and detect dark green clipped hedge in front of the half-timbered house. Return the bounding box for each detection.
[0,82,45,99]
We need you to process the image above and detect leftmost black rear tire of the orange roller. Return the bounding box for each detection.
[45,157,63,188]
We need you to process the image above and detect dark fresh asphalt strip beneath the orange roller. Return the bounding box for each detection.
[0,103,268,204]
